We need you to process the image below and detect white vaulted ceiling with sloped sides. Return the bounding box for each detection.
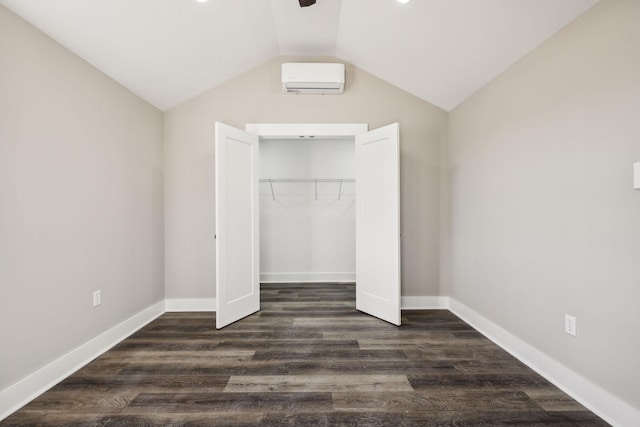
[0,0,598,110]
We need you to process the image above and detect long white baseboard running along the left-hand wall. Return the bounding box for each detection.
[0,301,164,420]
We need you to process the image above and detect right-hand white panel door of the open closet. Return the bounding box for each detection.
[356,123,401,325]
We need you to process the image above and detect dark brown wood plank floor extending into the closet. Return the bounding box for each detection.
[0,284,608,426]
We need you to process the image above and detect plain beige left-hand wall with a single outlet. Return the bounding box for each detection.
[0,6,164,390]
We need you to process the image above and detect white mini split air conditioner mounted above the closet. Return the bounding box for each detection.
[282,62,344,95]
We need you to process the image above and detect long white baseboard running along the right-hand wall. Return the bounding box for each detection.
[449,299,640,427]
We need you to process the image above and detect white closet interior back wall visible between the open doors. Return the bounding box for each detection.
[260,138,356,282]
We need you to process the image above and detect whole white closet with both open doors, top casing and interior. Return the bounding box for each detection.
[215,123,401,329]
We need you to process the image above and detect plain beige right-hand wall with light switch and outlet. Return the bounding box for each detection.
[444,0,640,408]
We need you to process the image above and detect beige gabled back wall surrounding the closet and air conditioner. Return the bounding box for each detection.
[165,57,447,298]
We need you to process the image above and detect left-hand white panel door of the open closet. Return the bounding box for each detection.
[215,123,260,329]
